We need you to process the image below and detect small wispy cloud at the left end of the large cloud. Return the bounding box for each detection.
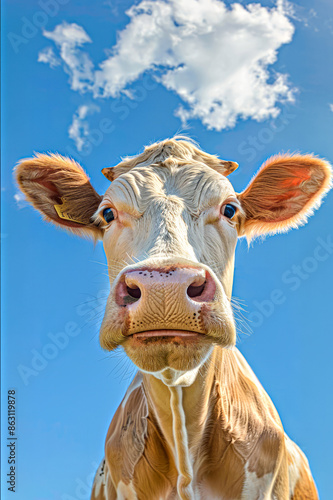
[43,22,94,92]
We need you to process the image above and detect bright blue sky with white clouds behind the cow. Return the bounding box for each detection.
[1,0,333,500]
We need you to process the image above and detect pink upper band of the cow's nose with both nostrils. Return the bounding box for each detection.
[116,267,216,306]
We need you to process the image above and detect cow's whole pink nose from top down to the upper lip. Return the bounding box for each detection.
[115,267,216,335]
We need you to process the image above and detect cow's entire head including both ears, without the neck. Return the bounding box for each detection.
[16,139,331,384]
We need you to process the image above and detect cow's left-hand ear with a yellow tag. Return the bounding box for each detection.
[15,154,102,238]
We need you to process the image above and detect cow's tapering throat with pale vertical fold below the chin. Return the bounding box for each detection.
[144,351,216,500]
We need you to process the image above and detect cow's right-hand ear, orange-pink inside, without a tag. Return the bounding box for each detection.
[238,155,332,239]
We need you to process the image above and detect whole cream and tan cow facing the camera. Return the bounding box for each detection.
[16,137,332,500]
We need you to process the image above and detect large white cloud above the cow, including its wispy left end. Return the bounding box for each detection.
[39,0,294,130]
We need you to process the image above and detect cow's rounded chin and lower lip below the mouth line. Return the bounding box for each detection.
[123,331,214,373]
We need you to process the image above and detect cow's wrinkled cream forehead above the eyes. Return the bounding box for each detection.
[103,163,235,213]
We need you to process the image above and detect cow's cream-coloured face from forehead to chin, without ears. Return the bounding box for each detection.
[96,163,242,378]
